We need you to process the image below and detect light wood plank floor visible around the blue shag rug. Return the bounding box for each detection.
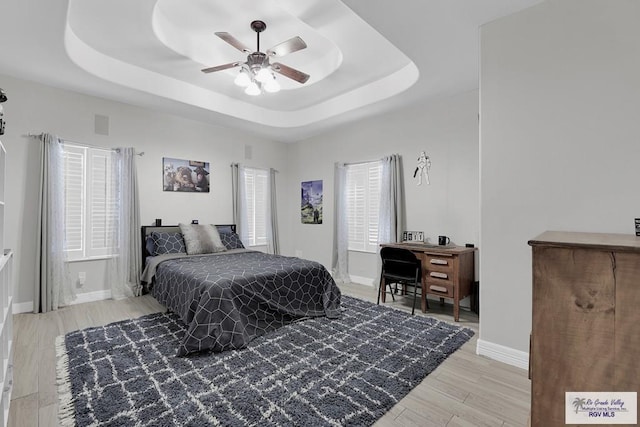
[9,284,530,427]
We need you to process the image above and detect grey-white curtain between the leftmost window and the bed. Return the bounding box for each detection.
[107,147,142,299]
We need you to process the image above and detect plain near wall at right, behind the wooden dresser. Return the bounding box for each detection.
[479,0,640,366]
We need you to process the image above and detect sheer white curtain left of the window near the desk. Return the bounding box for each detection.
[331,163,351,283]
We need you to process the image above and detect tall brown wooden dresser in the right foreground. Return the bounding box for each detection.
[529,231,640,427]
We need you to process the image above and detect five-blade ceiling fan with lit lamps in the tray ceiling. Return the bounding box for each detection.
[202,20,310,95]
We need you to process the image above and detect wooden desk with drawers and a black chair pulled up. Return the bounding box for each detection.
[380,243,476,322]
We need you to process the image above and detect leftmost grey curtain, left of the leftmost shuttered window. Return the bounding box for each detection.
[33,133,75,313]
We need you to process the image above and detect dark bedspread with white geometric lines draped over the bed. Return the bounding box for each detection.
[151,251,340,356]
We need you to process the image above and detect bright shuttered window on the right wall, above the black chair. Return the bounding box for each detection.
[346,161,382,252]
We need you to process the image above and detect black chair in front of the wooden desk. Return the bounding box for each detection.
[377,246,422,315]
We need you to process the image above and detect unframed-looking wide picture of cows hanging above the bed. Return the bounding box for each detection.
[162,157,210,193]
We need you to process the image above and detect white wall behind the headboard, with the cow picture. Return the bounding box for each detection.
[0,75,287,310]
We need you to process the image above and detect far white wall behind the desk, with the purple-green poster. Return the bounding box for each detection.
[287,91,479,284]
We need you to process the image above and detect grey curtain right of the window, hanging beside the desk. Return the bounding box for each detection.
[378,154,404,243]
